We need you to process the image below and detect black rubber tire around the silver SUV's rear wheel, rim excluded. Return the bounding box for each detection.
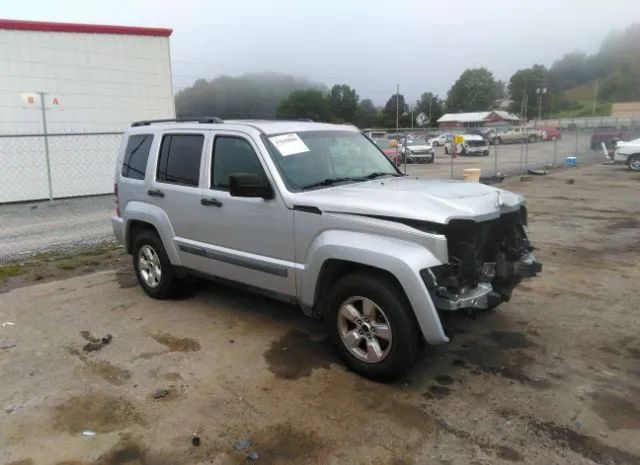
[132,230,178,299]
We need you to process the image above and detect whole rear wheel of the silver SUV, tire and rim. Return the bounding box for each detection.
[133,230,177,299]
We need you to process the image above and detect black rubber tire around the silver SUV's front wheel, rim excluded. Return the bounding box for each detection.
[324,272,420,381]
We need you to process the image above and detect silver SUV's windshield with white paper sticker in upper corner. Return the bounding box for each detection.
[265,131,398,191]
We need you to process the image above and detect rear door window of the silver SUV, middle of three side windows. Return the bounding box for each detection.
[157,134,204,186]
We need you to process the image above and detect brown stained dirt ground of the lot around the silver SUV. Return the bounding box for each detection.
[0,165,640,465]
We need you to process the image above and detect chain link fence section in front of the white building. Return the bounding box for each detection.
[0,132,122,203]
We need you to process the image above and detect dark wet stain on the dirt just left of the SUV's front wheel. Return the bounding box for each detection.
[264,329,333,379]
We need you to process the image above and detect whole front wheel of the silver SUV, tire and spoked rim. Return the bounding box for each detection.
[325,272,419,381]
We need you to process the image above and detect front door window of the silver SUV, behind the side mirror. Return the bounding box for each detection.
[211,136,265,190]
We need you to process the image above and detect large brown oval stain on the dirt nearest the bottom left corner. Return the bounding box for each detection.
[52,393,143,434]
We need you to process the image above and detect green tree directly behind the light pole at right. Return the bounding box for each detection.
[508,65,549,118]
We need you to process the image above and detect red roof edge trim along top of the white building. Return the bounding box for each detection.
[0,19,173,37]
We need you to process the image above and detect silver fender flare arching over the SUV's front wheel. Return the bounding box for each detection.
[296,230,449,345]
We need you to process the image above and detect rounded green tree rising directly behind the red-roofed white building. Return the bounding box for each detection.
[447,68,498,112]
